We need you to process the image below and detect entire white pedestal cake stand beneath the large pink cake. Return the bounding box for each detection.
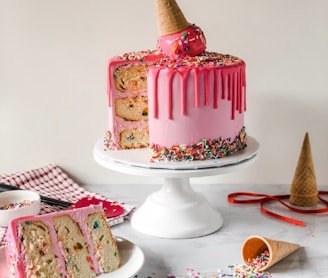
[93,137,259,238]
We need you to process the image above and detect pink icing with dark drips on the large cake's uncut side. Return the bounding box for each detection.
[148,53,246,147]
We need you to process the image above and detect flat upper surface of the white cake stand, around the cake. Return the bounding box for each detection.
[94,136,259,170]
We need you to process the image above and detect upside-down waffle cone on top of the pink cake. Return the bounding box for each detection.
[156,0,189,36]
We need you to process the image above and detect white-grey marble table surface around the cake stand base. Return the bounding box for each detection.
[85,183,328,278]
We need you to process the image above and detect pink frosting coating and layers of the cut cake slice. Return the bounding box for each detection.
[6,206,102,277]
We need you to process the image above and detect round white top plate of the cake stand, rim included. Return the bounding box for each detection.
[93,136,259,177]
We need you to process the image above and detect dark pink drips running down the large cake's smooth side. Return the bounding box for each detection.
[148,61,246,119]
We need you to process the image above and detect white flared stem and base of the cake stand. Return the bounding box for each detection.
[131,177,223,238]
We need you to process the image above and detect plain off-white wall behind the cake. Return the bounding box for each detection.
[0,0,328,185]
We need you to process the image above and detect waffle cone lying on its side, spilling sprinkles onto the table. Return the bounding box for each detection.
[242,236,301,271]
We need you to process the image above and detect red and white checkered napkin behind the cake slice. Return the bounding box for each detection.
[0,164,134,247]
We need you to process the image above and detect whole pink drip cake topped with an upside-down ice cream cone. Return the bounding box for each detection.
[105,0,247,162]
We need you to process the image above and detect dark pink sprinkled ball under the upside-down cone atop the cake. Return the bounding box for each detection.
[157,24,206,56]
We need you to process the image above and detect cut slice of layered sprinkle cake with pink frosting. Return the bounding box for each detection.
[6,206,120,278]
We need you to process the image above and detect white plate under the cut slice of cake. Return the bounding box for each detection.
[0,237,145,278]
